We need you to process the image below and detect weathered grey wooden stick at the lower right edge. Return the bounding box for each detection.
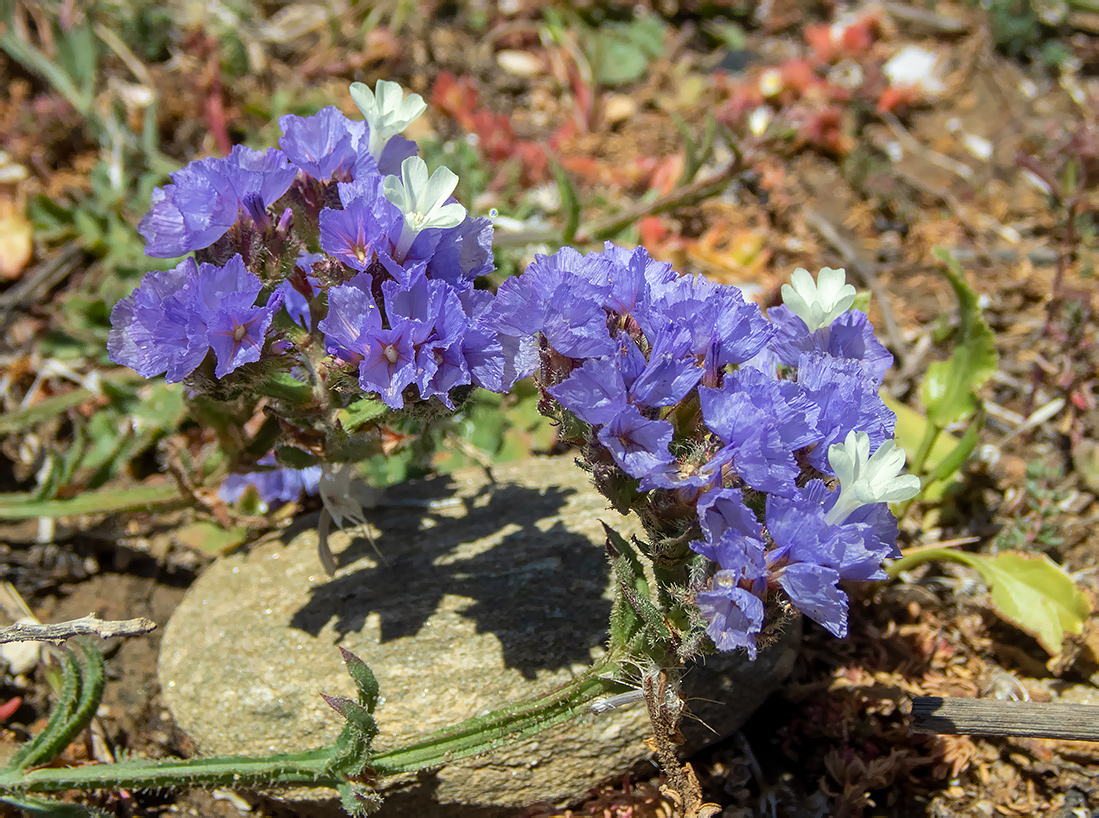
[912,696,1099,741]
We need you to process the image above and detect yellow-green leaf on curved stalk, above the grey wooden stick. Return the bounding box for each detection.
[888,549,1091,656]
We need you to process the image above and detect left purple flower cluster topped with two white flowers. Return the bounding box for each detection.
[109,82,514,409]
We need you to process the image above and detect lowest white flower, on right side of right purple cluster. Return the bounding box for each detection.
[824,432,920,526]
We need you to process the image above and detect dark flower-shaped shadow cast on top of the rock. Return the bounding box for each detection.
[290,478,610,678]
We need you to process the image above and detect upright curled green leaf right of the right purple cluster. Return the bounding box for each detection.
[921,247,998,428]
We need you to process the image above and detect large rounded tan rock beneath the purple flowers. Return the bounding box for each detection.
[159,457,800,816]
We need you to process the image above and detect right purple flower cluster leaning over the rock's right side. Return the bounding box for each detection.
[493,243,910,655]
